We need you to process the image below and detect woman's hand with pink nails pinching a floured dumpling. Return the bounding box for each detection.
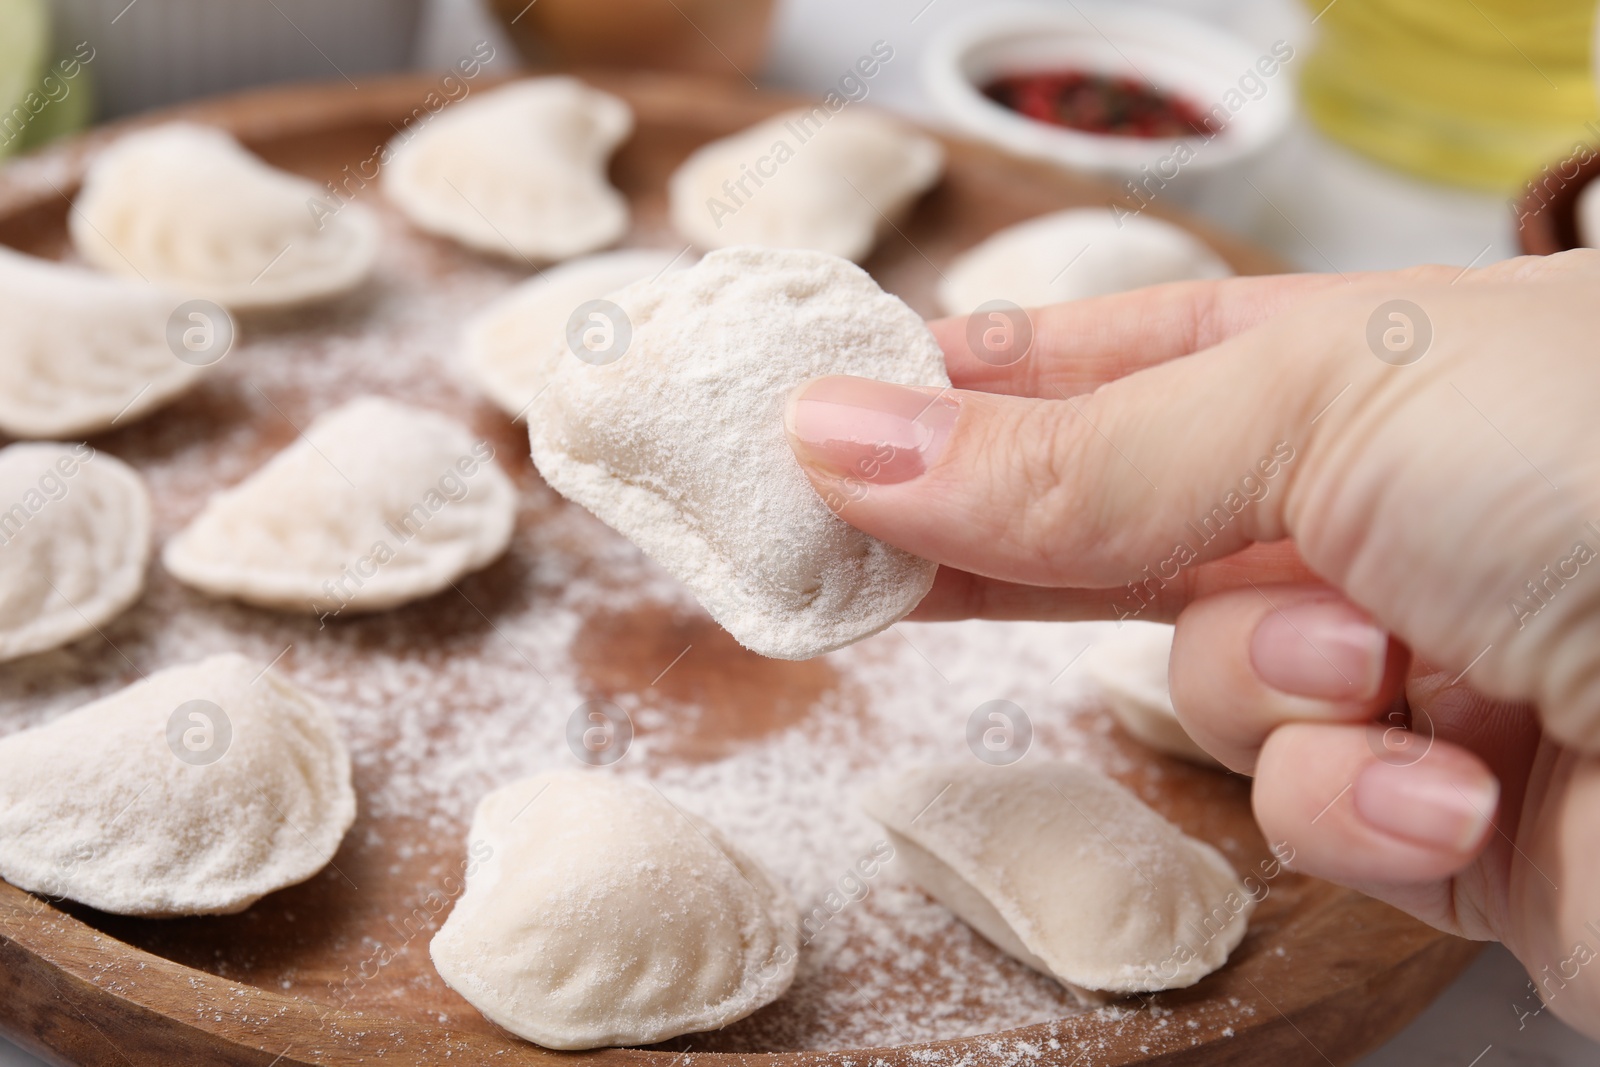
[787,251,1600,1037]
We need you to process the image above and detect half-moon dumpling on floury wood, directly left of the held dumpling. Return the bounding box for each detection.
[162,397,517,616]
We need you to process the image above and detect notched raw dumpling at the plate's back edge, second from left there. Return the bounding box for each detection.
[384,77,634,261]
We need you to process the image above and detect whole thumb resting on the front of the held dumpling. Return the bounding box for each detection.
[786,308,1347,587]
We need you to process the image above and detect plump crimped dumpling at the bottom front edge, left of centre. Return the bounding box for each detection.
[430,771,798,1049]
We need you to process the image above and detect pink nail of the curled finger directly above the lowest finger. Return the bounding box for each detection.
[1250,600,1389,701]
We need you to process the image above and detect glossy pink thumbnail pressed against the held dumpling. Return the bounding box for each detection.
[784,376,960,485]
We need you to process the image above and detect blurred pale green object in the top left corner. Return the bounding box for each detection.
[0,0,94,158]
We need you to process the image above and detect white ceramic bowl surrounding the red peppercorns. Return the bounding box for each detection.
[923,0,1294,176]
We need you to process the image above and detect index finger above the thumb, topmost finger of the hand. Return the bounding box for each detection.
[928,274,1354,400]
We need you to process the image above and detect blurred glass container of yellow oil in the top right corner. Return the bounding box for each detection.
[1301,0,1600,192]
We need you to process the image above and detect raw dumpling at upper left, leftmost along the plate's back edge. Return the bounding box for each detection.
[69,123,378,309]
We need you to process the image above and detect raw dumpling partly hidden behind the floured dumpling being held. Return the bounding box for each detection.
[466,248,694,418]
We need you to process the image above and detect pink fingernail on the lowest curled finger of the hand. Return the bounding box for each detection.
[1352,760,1499,853]
